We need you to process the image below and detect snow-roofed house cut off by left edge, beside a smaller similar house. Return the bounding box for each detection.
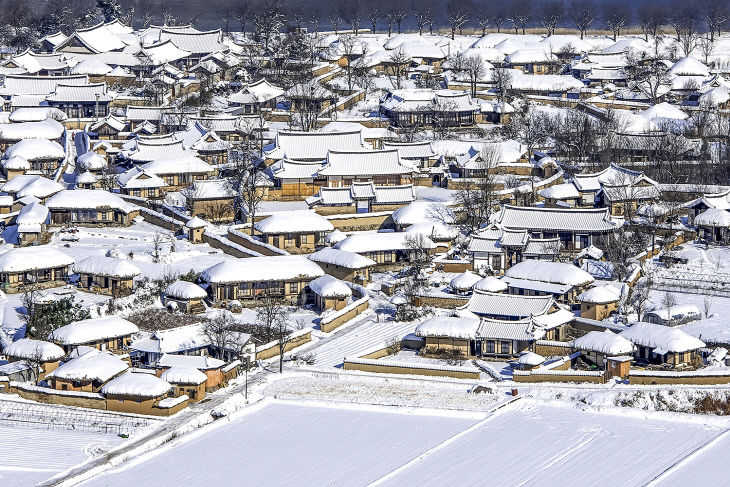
[0,247,74,293]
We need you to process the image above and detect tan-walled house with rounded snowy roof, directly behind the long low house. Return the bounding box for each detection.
[254,210,334,253]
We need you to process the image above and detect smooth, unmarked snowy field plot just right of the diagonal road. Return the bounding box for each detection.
[85,403,478,487]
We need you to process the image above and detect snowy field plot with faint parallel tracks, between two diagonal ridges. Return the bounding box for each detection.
[381,402,721,487]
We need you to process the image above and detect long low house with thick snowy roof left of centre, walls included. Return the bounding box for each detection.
[200,255,324,303]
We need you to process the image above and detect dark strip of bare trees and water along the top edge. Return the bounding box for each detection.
[0,0,730,41]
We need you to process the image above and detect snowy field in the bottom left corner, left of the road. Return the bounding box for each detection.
[0,424,124,487]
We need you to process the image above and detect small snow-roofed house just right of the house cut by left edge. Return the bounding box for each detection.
[73,256,142,297]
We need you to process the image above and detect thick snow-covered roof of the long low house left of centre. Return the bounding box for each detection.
[200,255,324,284]
